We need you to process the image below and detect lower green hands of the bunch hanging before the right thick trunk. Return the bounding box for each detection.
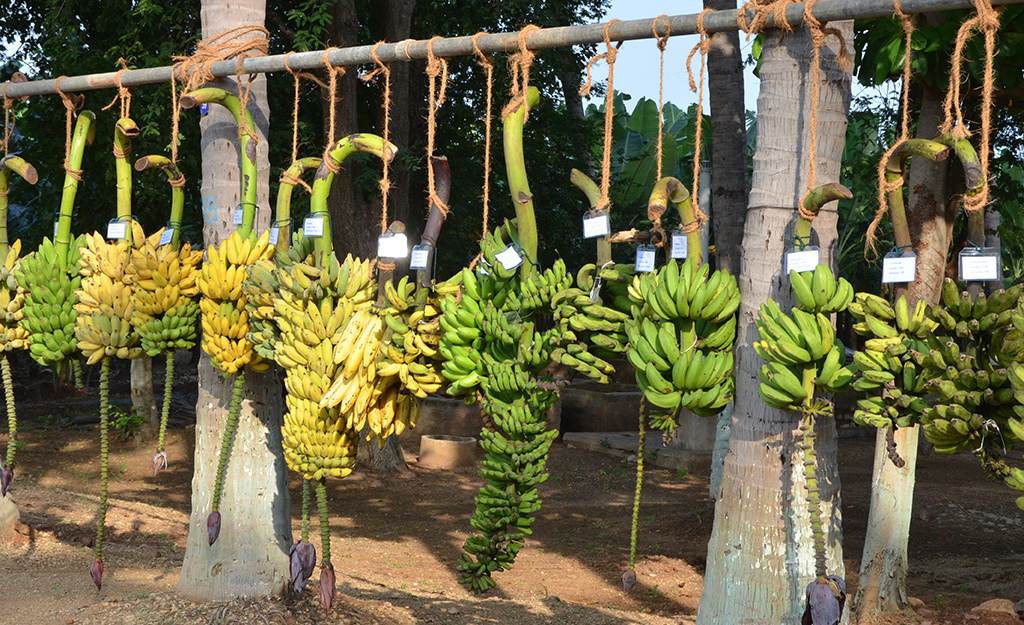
[754,299,854,414]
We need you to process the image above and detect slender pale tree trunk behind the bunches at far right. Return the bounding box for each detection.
[855,87,955,625]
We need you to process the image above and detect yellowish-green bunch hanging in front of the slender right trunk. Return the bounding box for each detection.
[849,293,938,428]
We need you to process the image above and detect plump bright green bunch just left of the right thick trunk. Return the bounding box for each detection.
[626,259,739,432]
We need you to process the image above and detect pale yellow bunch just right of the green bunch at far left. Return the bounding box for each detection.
[75,220,145,365]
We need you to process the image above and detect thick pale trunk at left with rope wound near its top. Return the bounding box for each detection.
[178,0,292,600]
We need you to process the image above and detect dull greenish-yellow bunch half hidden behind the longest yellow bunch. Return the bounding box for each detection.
[242,233,315,363]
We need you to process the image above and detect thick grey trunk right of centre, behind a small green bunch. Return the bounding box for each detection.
[697,22,853,625]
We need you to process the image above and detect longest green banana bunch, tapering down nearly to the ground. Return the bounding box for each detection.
[438,221,568,592]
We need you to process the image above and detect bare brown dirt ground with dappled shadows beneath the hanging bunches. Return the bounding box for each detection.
[0,360,1024,625]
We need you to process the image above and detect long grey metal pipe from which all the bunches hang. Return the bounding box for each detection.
[0,0,1024,97]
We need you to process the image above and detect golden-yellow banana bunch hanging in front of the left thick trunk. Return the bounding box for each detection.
[199,231,273,376]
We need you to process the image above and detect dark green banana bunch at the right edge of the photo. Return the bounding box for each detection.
[909,279,1024,452]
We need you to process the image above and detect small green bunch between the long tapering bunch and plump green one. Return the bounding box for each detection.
[551,263,634,383]
